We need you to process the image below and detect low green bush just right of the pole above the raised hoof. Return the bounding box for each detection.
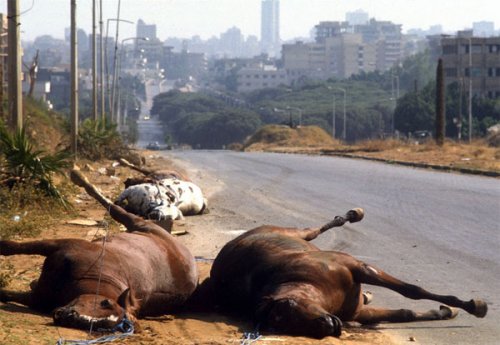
[78,119,127,160]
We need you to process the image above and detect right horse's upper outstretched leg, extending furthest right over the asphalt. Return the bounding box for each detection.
[351,261,488,317]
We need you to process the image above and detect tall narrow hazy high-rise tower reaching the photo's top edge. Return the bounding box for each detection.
[260,0,280,56]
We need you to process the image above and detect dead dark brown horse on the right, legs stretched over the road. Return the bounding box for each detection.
[210,209,487,338]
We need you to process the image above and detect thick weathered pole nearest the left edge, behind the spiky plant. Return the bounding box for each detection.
[7,0,23,129]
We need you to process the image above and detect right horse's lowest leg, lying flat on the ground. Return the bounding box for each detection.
[354,306,458,325]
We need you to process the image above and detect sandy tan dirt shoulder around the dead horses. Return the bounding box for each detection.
[0,152,398,345]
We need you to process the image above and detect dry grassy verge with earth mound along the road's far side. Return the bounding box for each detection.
[243,125,500,172]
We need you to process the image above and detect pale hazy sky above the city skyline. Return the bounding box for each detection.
[0,0,500,40]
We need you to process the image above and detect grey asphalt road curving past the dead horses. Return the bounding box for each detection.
[165,151,500,345]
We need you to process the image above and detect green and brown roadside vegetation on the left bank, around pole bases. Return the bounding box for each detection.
[0,98,132,239]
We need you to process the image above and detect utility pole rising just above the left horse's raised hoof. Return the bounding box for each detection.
[71,0,78,153]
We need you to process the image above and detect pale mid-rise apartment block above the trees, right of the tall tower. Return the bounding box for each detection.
[282,19,403,82]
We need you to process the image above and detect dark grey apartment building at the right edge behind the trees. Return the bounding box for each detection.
[441,30,500,98]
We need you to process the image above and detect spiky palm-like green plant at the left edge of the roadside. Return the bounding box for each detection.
[0,126,70,204]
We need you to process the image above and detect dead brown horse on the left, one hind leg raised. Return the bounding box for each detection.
[0,171,198,330]
